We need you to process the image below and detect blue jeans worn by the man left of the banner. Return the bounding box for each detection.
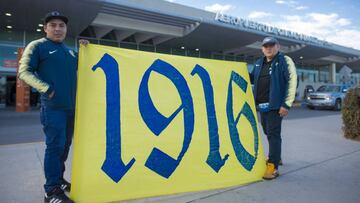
[40,106,74,193]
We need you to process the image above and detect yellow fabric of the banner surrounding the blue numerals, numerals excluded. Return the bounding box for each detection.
[71,44,265,203]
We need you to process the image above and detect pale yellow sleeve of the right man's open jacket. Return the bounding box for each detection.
[285,56,297,107]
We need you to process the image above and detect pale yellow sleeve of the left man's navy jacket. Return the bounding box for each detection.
[19,38,49,93]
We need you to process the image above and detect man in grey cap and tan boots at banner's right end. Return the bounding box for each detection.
[250,37,297,180]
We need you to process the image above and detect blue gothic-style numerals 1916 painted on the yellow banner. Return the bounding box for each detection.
[92,54,259,182]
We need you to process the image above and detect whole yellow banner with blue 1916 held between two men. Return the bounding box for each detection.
[71,45,265,203]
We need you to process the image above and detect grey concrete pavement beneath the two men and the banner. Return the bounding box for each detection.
[0,110,360,203]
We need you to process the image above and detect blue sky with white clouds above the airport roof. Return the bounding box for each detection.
[168,0,360,50]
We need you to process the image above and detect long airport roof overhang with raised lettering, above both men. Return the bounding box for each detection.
[0,0,360,72]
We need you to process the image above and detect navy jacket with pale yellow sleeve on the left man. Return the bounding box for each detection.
[19,38,78,110]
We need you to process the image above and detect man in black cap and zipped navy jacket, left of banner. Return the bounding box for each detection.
[19,11,89,203]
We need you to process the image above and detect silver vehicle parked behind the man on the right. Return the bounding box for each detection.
[305,84,351,111]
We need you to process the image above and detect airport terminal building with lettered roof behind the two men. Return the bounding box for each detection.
[0,0,360,106]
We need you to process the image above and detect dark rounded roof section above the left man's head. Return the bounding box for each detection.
[0,0,101,37]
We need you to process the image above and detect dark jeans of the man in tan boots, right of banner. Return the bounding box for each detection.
[260,110,282,169]
